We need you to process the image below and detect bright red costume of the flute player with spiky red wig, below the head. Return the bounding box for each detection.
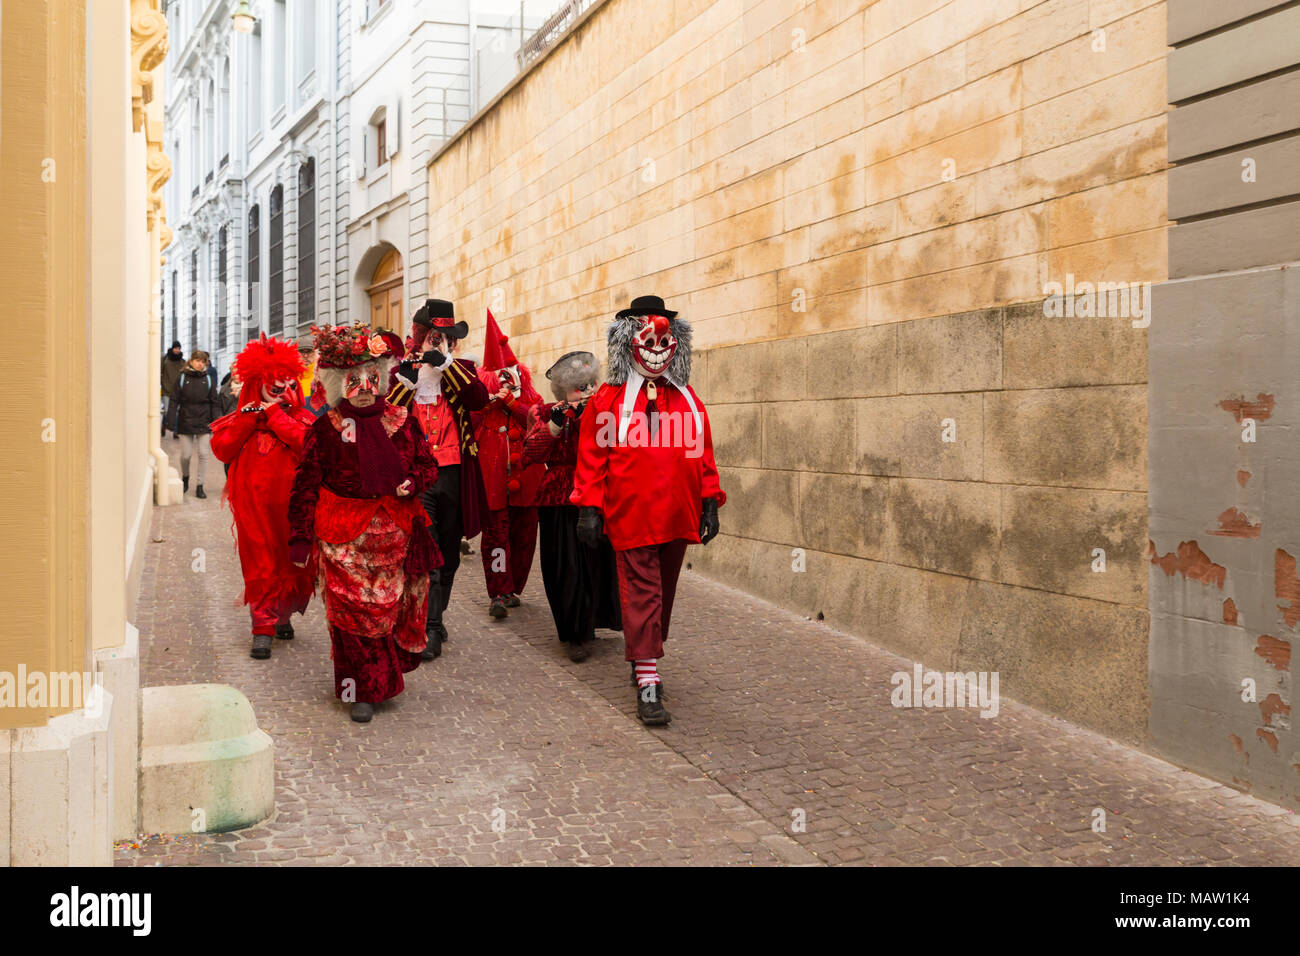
[212,405,315,610]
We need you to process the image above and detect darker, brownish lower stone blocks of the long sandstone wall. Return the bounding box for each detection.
[688,303,1148,739]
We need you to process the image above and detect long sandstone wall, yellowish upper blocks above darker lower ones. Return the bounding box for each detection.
[430,0,1167,740]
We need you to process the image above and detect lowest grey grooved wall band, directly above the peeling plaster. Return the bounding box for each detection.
[1169,202,1300,278]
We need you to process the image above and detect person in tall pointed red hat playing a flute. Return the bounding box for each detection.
[477,310,546,618]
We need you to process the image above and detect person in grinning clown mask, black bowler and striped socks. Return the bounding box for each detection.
[569,295,727,726]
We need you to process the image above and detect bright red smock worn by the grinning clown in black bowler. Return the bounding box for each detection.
[569,378,727,551]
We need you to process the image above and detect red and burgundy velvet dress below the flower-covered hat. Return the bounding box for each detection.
[289,399,442,704]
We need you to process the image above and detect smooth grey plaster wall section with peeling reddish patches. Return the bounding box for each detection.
[1148,265,1300,805]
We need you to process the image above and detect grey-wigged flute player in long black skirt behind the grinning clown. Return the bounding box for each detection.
[524,351,623,663]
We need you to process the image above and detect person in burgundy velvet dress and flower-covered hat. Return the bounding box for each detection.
[289,325,442,723]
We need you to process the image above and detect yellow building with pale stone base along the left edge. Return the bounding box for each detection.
[0,0,172,865]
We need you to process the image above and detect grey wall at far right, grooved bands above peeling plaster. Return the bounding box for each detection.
[1149,0,1300,805]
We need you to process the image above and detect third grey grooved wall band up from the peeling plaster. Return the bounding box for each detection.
[1169,69,1300,163]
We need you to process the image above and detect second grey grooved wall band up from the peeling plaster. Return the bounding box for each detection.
[1169,133,1300,220]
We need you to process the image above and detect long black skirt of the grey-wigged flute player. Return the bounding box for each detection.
[537,505,623,644]
